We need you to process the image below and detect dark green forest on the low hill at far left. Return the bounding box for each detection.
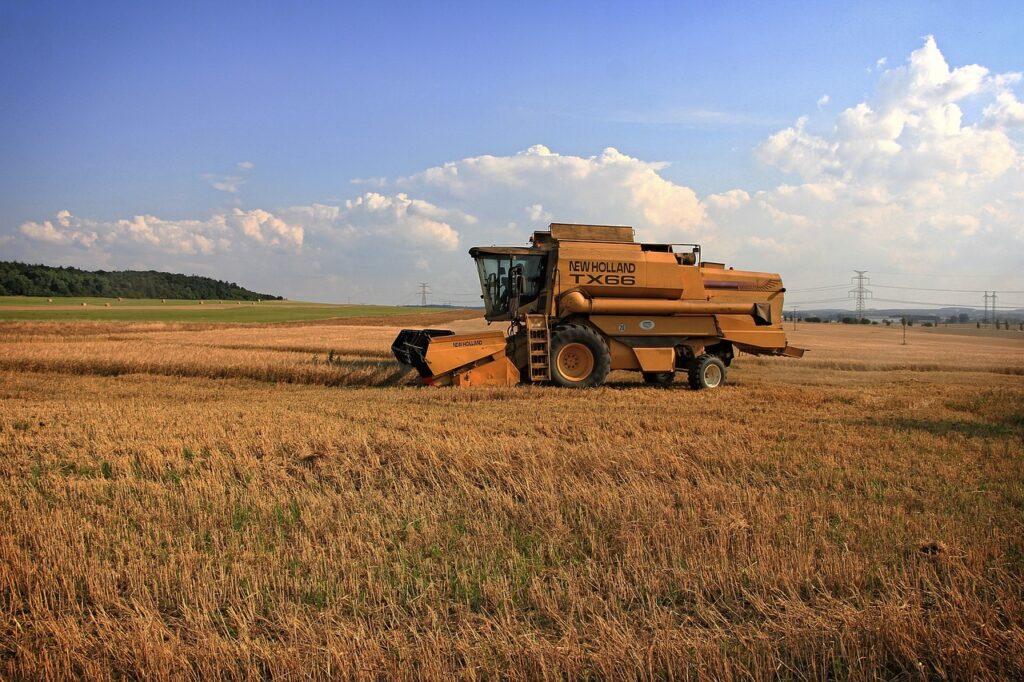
[0,261,282,301]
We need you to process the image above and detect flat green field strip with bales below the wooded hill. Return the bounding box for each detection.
[0,296,445,323]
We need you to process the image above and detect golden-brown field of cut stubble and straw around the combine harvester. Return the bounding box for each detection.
[0,319,1024,679]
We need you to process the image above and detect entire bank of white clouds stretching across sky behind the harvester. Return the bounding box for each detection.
[7,37,1024,302]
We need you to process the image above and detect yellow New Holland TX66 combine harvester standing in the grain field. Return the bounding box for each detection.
[391,223,804,388]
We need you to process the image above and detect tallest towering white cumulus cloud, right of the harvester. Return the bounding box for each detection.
[724,37,1024,278]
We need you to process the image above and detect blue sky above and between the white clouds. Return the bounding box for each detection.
[0,2,1024,298]
